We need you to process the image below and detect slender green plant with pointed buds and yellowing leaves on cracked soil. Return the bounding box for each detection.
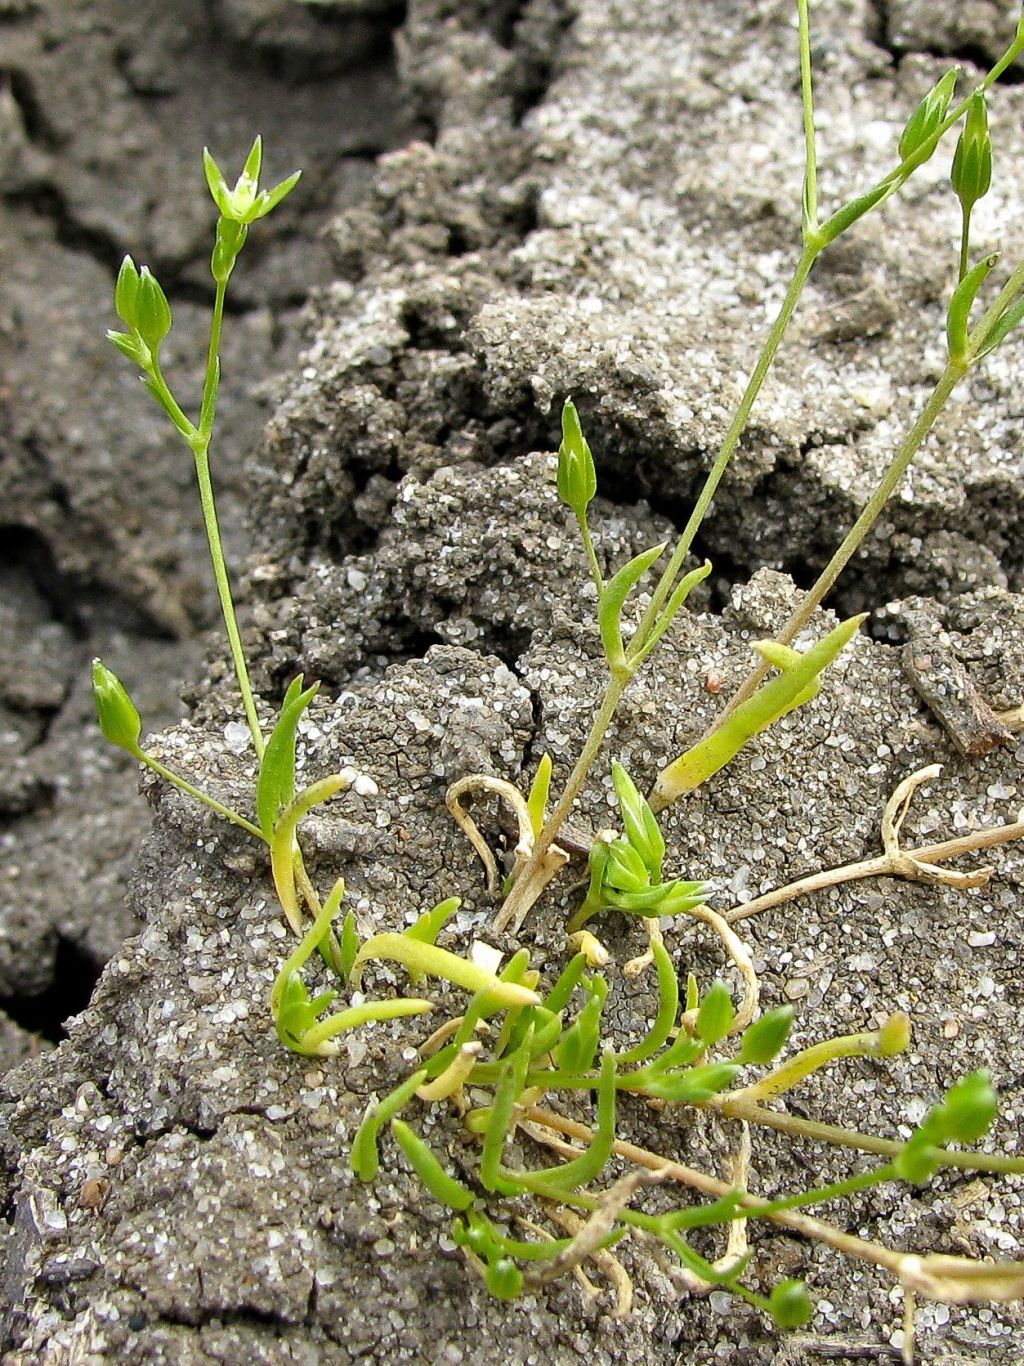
[93,8,1024,1344]
